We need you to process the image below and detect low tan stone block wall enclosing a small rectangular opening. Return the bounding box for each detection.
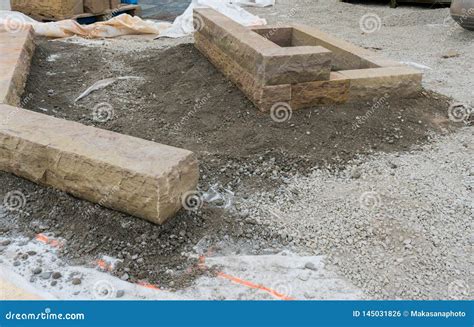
[194,9,422,111]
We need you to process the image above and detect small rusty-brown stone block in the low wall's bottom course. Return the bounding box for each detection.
[290,73,350,110]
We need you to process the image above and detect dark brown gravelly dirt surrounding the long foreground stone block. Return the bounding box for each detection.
[1,35,449,287]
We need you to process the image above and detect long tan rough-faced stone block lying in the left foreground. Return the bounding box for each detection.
[0,105,199,224]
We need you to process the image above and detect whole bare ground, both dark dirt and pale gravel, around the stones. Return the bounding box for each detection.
[0,1,474,298]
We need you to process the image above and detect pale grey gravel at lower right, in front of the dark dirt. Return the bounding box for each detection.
[240,128,474,299]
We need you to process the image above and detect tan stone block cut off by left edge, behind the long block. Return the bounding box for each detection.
[0,27,34,106]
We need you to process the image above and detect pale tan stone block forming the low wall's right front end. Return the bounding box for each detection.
[339,67,422,102]
